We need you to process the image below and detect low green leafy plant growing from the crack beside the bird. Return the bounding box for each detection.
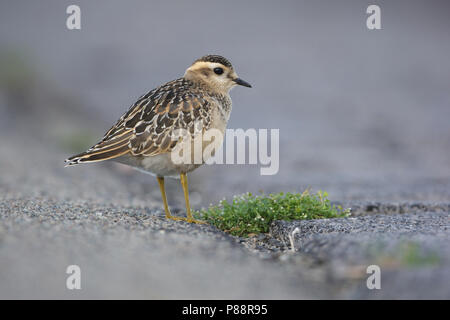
[194,190,350,236]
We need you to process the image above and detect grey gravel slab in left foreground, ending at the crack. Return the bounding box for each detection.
[0,198,320,299]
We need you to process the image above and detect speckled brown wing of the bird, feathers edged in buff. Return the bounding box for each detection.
[66,78,213,165]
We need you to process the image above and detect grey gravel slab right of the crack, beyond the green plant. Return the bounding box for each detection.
[270,211,450,299]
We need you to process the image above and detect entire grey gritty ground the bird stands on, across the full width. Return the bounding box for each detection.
[0,131,450,299]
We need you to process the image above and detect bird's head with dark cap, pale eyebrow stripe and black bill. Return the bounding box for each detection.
[184,55,252,93]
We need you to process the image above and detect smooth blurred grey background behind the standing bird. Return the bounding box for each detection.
[0,0,450,207]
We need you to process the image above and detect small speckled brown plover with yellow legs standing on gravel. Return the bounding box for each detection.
[65,55,252,223]
